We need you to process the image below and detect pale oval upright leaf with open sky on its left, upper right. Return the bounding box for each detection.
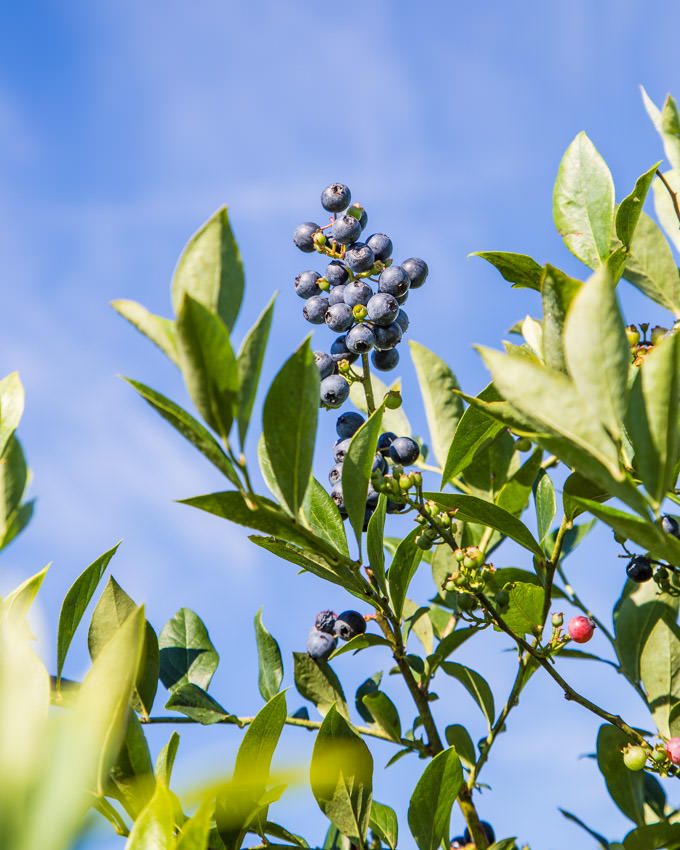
[553,132,614,268]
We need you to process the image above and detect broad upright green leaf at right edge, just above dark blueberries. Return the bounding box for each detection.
[627,334,680,507]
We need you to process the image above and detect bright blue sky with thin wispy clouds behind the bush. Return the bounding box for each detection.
[0,0,680,850]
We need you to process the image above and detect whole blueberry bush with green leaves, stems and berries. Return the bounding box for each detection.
[6,88,680,850]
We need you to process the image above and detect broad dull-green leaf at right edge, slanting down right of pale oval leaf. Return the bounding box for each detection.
[623,213,680,317]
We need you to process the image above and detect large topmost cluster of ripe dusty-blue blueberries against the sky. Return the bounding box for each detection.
[293,183,428,407]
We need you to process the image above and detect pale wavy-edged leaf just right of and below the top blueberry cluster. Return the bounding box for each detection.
[409,340,463,466]
